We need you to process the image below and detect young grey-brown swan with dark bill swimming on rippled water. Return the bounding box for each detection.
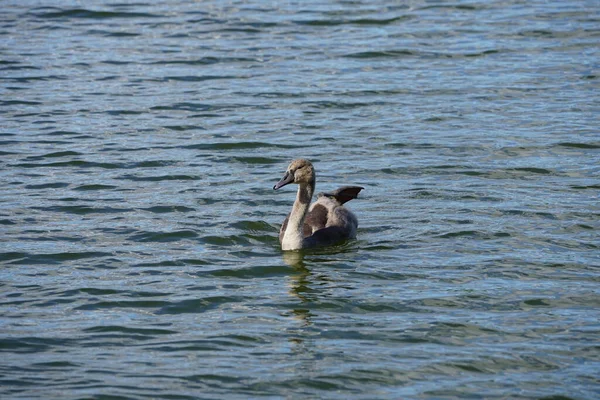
[273,159,364,250]
